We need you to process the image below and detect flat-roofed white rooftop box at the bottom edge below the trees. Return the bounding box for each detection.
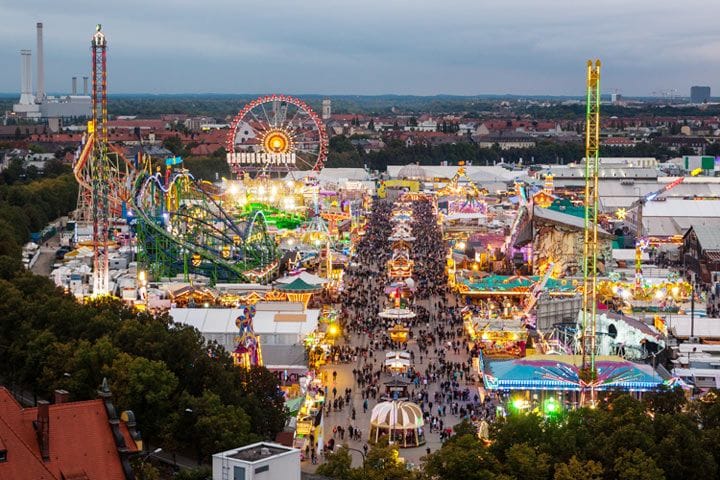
[213,442,300,480]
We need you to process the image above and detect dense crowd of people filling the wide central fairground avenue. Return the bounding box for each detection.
[316,195,490,464]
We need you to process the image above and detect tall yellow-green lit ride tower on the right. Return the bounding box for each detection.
[581,60,601,390]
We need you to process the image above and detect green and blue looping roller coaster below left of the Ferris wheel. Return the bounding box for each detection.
[132,159,278,282]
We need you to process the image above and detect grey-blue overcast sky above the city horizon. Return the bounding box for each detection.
[0,0,720,95]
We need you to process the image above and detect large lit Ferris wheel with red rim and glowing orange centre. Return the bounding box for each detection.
[225,95,328,174]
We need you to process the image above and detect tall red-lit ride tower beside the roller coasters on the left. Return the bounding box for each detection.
[89,25,110,295]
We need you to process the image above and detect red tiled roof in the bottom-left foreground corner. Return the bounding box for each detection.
[0,387,137,480]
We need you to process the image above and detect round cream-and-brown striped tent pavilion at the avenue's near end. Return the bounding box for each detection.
[368,401,425,448]
